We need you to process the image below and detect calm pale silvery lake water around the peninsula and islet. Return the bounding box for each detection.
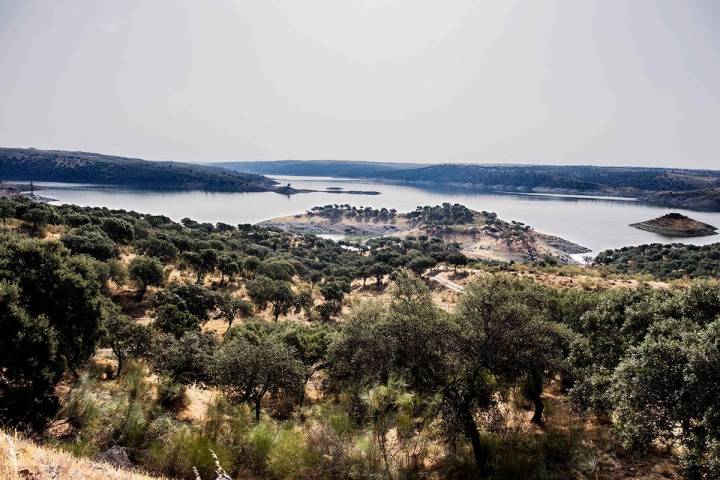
[31,176,720,252]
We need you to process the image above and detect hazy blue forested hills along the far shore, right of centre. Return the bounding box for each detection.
[224,161,720,211]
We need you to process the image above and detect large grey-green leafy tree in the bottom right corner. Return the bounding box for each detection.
[611,319,720,479]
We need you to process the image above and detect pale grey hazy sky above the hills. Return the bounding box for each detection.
[0,0,720,168]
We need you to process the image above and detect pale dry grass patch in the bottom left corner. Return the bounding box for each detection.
[0,431,161,480]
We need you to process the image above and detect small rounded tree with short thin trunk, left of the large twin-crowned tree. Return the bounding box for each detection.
[212,336,305,421]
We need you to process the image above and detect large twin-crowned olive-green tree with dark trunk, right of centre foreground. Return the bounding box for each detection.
[328,271,566,471]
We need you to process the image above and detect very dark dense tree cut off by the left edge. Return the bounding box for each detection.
[0,234,106,429]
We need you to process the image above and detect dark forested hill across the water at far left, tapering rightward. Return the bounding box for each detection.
[0,148,275,192]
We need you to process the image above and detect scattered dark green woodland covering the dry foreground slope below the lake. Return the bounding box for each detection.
[0,198,720,479]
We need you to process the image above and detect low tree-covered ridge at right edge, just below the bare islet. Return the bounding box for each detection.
[595,243,720,279]
